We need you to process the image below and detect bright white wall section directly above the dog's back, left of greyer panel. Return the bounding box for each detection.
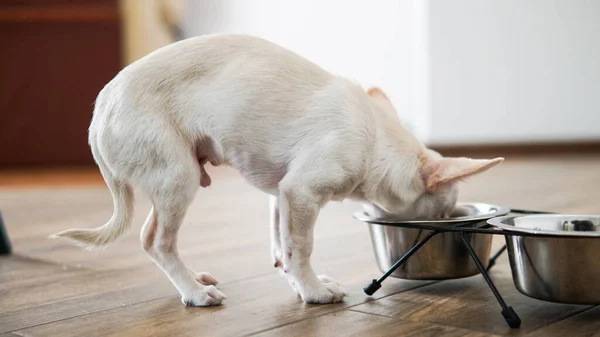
[184,0,422,136]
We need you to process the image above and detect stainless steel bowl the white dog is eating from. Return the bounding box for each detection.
[354,203,510,280]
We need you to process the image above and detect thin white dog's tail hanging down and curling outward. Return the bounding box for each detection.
[50,133,134,248]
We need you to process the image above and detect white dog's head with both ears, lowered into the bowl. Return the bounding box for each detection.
[365,88,504,220]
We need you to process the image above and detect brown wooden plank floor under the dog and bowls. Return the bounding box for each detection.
[0,155,600,337]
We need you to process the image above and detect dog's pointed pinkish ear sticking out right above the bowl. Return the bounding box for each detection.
[421,157,504,193]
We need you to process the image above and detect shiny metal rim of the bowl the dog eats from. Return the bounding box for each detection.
[353,202,510,225]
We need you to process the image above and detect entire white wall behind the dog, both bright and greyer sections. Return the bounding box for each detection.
[184,0,600,145]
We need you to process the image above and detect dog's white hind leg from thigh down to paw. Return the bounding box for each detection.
[141,155,225,306]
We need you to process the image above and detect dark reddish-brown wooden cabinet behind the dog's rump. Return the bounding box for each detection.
[0,0,122,168]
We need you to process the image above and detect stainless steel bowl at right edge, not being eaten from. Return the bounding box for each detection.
[487,214,600,304]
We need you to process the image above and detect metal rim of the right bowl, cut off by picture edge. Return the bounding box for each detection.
[487,213,600,238]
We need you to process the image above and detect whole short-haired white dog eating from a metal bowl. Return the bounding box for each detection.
[50,34,503,306]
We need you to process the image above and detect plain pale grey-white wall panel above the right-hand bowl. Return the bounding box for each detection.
[428,0,600,144]
